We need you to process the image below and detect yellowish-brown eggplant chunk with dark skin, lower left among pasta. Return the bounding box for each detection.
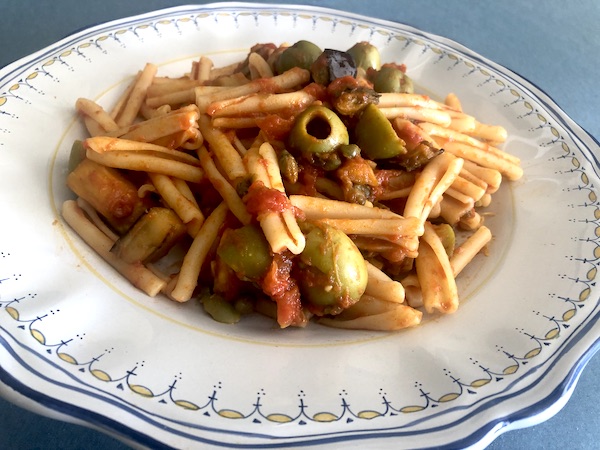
[111,207,187,263]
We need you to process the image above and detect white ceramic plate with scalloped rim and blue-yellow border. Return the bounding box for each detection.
[0,4,600,448]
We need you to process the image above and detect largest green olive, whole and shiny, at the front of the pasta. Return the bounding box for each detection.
[298,222,367,314]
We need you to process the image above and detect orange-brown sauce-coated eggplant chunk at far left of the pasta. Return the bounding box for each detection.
[67,158,146,235]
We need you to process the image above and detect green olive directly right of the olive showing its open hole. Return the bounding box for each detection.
[354,104,406,159]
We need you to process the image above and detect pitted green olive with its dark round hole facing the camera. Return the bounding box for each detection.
[289,105,350,159]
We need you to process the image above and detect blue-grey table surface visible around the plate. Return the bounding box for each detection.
[0,0,600,450]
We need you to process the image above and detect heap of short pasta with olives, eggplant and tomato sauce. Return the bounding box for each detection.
[62,41,523,331]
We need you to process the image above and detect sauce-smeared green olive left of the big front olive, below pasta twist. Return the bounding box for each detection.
[217,225,273,280]
